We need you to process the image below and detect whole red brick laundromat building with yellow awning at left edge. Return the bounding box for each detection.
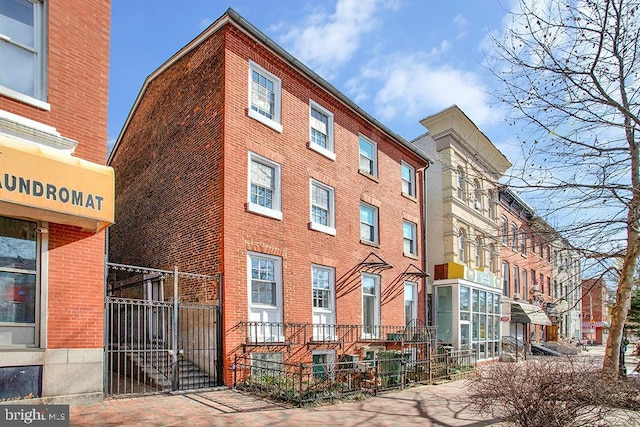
[0,0,114,402]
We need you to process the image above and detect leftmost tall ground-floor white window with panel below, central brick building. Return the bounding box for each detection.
[248,253,284,342]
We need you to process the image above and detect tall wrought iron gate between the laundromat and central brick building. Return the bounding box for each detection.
[104,263,222,396]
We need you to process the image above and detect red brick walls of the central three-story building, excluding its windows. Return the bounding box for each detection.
[110,12,426,383]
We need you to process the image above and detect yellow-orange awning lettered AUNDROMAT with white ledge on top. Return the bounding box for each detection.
[0,133,115,231]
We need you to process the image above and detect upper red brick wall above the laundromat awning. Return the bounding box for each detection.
[0,0,111,164]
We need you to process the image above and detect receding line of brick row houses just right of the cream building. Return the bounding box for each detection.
[500,187,580,342]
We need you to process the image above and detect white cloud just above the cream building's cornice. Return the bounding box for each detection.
[350,54,503,126]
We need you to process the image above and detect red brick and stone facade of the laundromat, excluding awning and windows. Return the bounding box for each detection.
[0,0,111,403]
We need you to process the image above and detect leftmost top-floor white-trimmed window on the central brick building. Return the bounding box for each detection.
[249,61,282,132]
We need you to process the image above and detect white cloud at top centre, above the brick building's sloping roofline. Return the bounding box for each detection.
[280,0,388,78]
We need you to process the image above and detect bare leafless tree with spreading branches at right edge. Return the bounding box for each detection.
[489,0,640,375]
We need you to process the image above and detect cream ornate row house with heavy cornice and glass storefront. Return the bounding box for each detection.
[413,105,511,360]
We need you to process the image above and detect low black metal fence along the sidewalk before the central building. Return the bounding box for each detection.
[233,347,477,406]
